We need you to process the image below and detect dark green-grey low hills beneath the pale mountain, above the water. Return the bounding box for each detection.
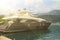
[39,15,60,22]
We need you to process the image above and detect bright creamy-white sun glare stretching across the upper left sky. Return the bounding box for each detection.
[0,0,43,14]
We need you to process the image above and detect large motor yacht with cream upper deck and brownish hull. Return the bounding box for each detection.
[0,9,51,32]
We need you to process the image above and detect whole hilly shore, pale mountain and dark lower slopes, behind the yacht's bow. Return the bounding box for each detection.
[37,10,60,23]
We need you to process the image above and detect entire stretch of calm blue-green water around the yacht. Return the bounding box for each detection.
[0,24,60,40]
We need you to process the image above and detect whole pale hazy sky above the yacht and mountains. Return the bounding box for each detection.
[0,0,60,15]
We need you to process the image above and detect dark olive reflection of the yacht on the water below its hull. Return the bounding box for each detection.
[0,30,49,40]
